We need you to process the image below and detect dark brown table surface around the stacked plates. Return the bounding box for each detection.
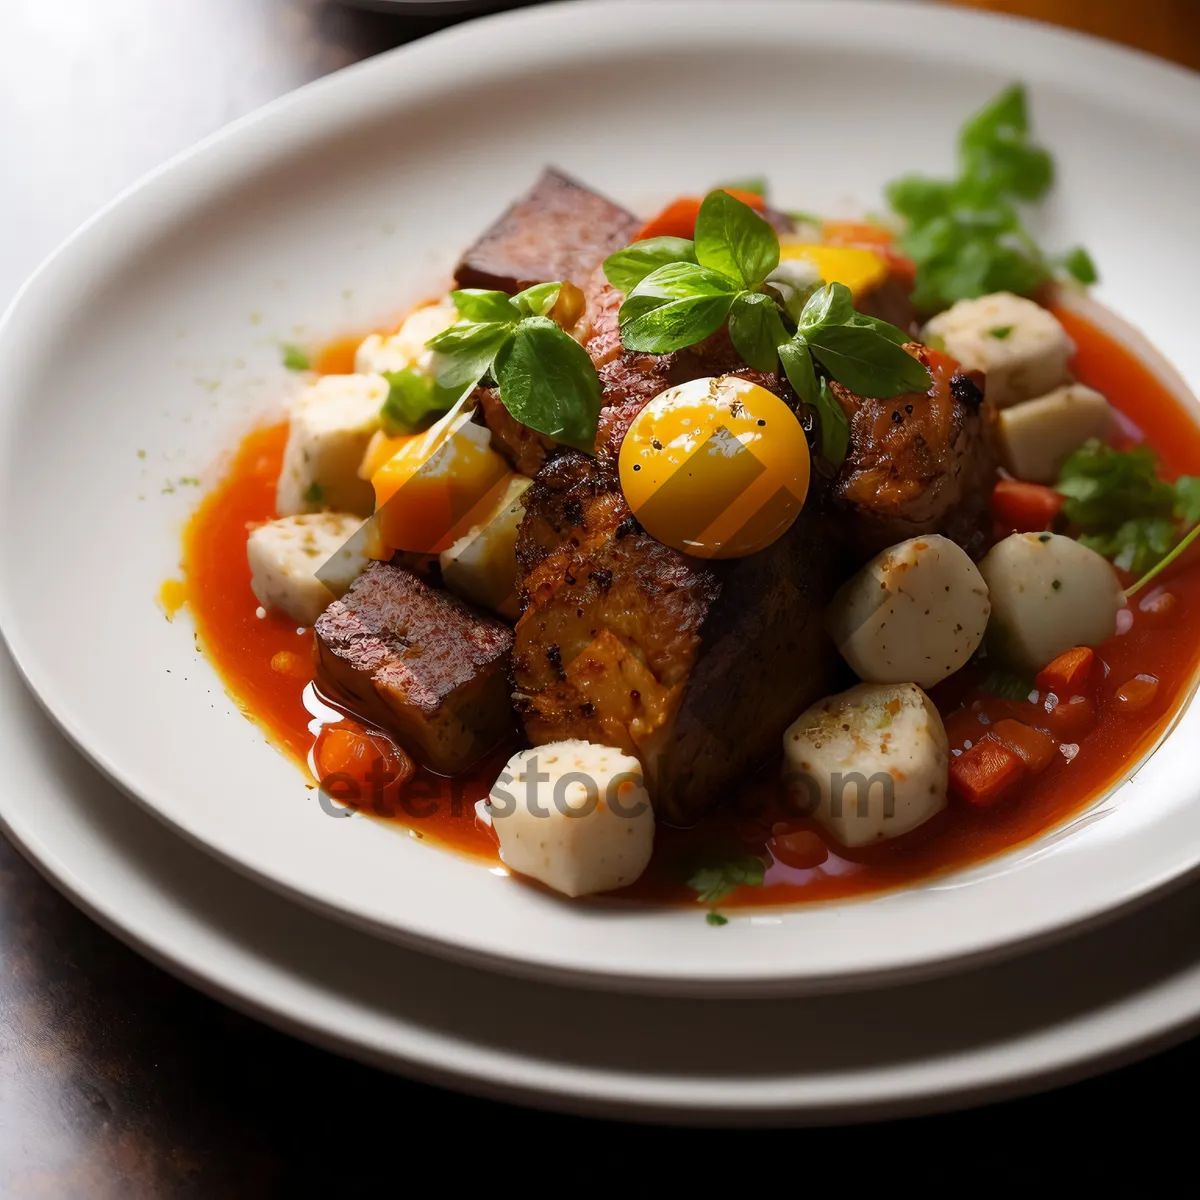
[0,0,1200,1200]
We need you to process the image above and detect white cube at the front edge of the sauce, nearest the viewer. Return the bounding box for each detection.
[487,742,654,896]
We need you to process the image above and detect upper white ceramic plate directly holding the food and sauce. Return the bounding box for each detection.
[0,2,1200,994]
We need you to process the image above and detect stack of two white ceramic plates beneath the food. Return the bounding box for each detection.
[0,2,1200,1121]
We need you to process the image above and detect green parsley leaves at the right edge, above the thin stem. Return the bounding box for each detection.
[1055,438,1200,575]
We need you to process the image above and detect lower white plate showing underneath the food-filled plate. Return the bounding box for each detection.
[0,649,1200,1124]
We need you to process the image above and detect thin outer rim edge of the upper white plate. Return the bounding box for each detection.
[0,0,1200,995]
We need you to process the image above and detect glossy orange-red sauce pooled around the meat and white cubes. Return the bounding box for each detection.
[185,311,1200,907]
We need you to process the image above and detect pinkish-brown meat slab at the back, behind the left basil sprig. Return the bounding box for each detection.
[455,168,641,294]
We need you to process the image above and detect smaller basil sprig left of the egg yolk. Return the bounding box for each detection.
[420,283,600,452]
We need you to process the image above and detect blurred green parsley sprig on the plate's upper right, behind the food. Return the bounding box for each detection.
[887,84,1097,312]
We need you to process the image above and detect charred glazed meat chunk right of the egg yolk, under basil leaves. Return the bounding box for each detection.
[833,343,996,557]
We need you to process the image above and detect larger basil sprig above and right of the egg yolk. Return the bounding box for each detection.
[604,191,932,466]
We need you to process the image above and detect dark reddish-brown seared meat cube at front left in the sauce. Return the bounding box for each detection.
[314,563,514,775]
